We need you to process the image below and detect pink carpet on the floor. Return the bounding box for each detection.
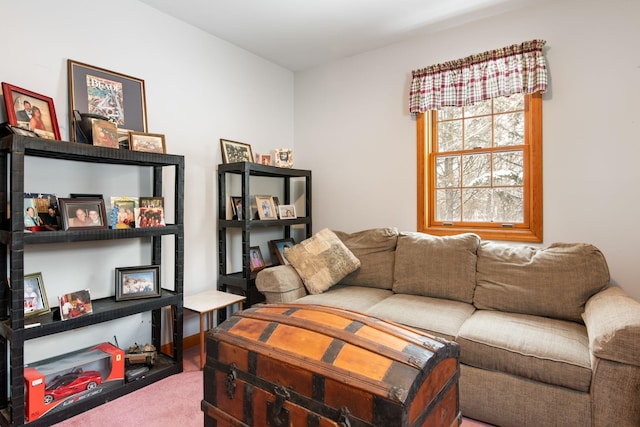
[55,347,489,427]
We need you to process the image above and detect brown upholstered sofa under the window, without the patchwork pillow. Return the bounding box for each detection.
[256,228,640,427]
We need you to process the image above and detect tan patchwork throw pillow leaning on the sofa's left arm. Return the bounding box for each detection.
[284,228,360,294]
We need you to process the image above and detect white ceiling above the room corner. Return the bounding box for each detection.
[140,0,539,71]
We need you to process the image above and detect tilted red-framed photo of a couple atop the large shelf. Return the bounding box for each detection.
[2,82,60,140]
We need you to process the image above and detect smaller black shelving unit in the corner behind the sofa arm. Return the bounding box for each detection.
[218,162,312,307]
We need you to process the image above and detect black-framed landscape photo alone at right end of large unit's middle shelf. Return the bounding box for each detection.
[116,265,161,301]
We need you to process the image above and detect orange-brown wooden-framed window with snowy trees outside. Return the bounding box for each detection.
[417,92,542,242]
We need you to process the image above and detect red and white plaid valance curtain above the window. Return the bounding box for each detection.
[409,40,547,113]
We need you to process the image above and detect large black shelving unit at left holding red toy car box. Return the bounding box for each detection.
[0,135,185,426]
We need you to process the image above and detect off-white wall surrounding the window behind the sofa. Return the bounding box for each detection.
[295,0,640,298]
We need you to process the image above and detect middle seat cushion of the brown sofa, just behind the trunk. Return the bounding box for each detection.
[366,294,475,340]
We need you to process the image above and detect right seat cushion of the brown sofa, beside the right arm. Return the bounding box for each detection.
[456,310,591,392]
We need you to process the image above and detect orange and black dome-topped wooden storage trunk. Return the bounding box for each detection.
[202,304,460,427]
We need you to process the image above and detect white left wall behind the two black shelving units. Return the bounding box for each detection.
[0,0,294,357]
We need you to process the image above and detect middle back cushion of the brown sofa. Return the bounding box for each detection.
[393,232,480,303]
